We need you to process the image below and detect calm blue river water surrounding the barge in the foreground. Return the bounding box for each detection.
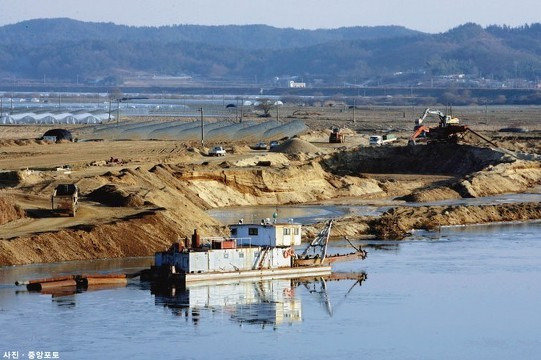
[0,223,541,360]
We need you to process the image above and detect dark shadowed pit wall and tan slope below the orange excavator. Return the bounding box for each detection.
[324,144,541,202]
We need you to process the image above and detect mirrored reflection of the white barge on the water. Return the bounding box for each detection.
[151,273,366,328]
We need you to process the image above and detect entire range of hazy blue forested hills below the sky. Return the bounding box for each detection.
[0,19,541,84]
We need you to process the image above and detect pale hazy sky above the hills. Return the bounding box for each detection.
[0,0,541,32]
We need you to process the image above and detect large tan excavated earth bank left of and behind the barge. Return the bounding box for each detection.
[0,162,382,266]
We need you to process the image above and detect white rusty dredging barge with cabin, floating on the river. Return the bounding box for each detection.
[141,219,366,284]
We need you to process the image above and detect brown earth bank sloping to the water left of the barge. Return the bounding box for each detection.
[0,211,220,266]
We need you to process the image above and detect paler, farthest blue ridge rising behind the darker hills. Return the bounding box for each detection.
[0,18,419,50]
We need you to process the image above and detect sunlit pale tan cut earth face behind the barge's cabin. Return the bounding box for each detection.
[167,161,382,208]
